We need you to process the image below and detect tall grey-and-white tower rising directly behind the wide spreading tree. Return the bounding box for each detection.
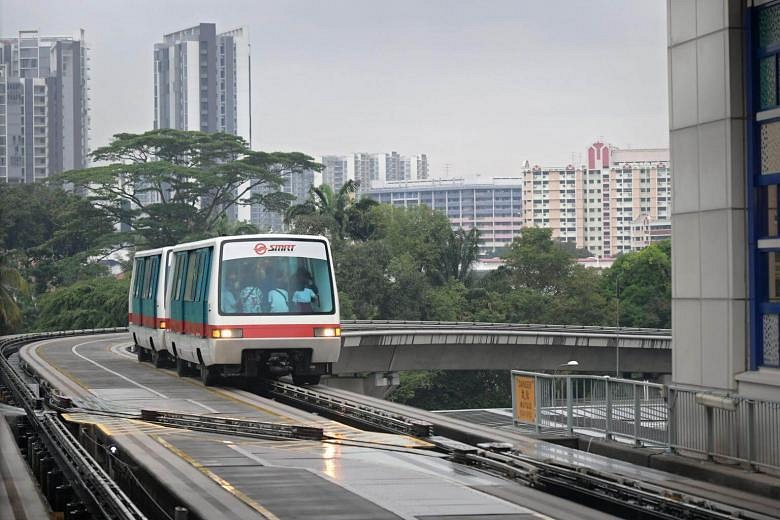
[154,23,252,145]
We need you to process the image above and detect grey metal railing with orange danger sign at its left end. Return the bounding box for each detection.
[512,370,780,472]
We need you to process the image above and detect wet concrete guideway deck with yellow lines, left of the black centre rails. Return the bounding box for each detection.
[4,334,610,520]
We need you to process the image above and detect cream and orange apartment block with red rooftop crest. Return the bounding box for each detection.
[523,142,671,257]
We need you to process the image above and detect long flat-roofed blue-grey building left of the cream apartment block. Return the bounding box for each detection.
[363,178,523,256]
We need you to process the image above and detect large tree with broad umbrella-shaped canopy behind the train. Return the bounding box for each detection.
[52,129,320,247]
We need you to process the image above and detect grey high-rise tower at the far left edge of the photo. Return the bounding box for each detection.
[0,31,89,183]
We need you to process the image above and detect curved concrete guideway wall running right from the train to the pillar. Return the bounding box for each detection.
[333,321,672,390]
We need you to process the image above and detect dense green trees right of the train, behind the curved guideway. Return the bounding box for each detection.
[288,188,671,408]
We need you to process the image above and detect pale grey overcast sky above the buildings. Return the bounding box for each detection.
[0,0,668,178]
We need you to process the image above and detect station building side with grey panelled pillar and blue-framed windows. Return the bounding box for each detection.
[668,0,780,398]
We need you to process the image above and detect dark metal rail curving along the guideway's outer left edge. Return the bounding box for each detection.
[0,329,146,520]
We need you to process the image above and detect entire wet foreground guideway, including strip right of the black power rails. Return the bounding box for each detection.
[3,334,768,520]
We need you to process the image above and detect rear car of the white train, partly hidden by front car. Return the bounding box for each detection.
[127,247,173,367]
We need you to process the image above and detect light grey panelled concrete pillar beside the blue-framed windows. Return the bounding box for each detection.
[668,0,747,390]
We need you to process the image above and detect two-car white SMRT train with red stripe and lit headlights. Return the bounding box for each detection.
[128,235,341,386]
